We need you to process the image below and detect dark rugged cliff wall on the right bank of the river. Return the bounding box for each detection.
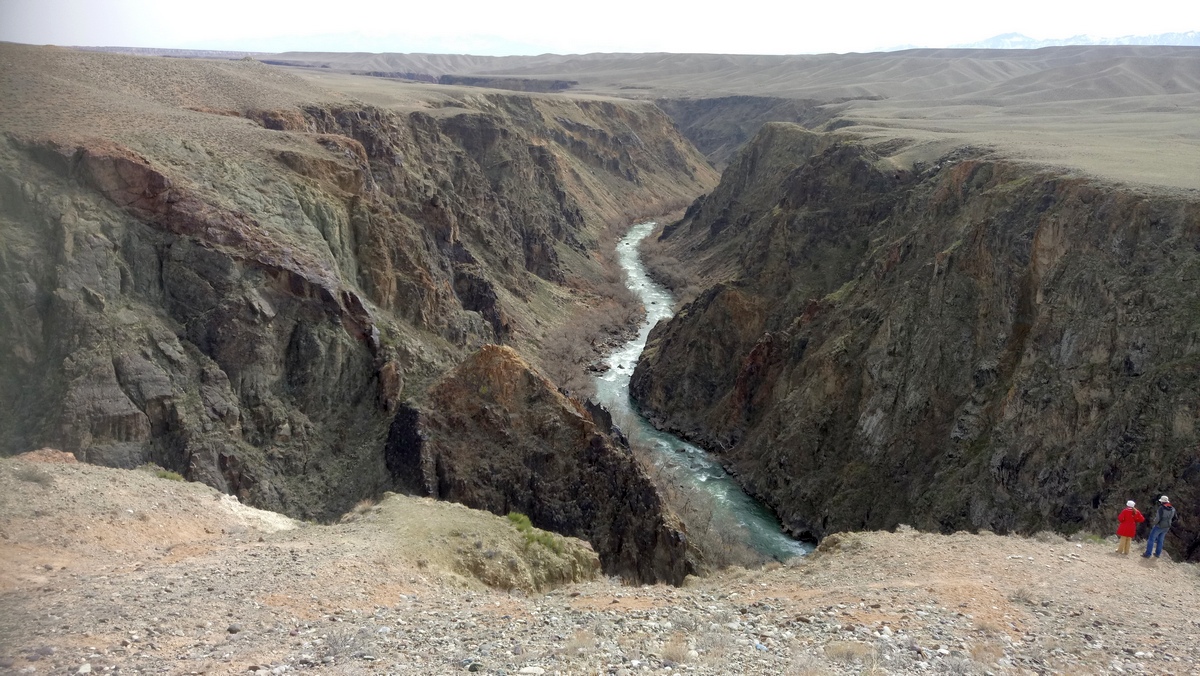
[634,124,1200,560]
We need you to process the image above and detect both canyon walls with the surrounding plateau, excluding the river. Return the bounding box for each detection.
[7,44,1200,571]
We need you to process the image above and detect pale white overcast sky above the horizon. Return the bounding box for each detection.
[0,0,1200,55]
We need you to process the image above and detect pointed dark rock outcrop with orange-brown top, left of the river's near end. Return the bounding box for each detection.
[386,346,696,585]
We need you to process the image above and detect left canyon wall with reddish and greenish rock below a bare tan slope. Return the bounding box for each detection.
[0,46,713,535]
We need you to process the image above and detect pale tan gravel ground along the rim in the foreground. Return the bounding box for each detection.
[0,460,1200,675]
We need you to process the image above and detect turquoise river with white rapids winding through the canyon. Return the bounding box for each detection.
[596,222,812,561]
